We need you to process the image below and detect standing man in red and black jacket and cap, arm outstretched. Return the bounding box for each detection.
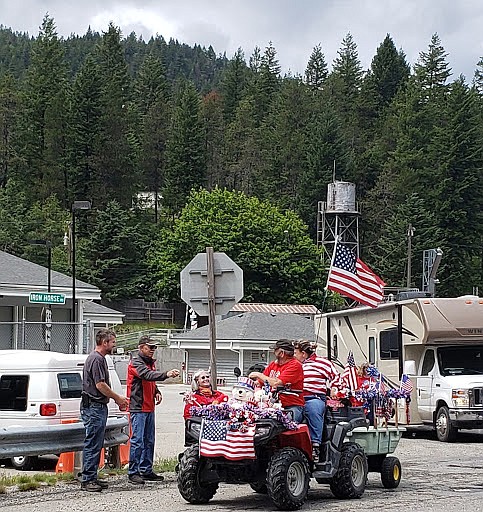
[126,336,179,485]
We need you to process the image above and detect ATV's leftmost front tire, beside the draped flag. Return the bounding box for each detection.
[178,444,218,505]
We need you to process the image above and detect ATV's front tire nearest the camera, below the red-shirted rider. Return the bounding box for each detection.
[267,447,310,510]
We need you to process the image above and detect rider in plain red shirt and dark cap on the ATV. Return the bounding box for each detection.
[249,340,305,423]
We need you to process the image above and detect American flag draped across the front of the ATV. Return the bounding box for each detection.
[200,419,255,460]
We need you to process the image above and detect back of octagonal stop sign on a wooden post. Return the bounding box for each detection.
[180,247,243,390]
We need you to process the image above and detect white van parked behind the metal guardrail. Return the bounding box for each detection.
[0,350,125,469]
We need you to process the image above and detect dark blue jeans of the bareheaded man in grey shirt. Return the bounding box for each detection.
[81,402,107,482]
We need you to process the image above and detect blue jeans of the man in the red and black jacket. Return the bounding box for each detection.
[128,412,155,475]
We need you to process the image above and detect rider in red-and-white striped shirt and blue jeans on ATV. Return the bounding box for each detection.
[294,340,340,458]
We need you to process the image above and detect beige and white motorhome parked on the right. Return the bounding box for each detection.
[315,296,483,442]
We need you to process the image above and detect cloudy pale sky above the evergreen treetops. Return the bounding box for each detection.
[0,0,483,81]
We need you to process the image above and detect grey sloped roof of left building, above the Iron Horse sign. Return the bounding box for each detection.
[0,251,100,299]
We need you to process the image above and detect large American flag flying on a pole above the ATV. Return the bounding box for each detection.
[327,243,386,308]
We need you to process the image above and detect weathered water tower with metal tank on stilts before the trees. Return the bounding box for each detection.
[317,181,360,261]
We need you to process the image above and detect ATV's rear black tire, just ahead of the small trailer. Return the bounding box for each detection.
[330,443,367,499]
